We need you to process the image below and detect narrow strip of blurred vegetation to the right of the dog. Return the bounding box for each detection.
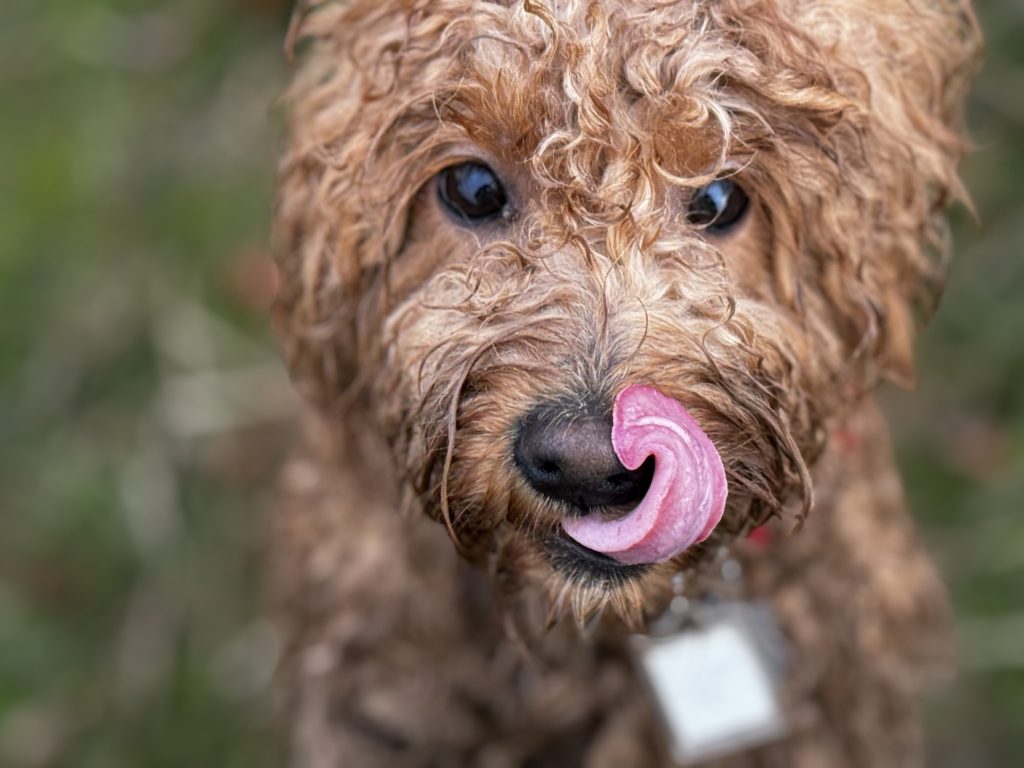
[887,0,1024,768]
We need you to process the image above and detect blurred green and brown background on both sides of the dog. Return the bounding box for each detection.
[0,0,1024,768]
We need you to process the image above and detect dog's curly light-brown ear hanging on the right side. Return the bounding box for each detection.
[755,0,980,386]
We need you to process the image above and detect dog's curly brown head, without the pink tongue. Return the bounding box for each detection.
[278,0,974,612]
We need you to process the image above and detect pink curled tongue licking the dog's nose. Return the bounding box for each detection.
[562,386,727,565]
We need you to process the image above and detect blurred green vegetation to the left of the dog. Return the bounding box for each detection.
[0,0,292,768]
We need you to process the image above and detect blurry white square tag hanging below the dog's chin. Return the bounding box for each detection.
[633,603,785,765]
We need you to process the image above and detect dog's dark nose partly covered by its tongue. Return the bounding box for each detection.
[513,407,654,512]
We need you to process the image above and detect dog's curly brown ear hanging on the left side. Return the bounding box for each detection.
[273,0,408,409]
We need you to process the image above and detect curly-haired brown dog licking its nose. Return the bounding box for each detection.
[273,0,979,768]
